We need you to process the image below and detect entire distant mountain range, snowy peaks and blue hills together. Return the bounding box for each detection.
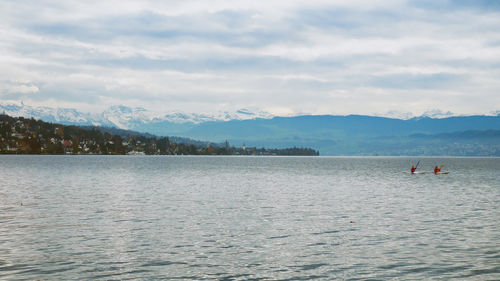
[0,102,500,155]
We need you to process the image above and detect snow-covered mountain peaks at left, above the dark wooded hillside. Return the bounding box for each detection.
[0,101,273,131]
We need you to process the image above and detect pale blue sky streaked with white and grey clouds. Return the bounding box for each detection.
[0,0,500,116]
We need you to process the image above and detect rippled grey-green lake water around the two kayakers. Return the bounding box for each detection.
[0,155,500,280]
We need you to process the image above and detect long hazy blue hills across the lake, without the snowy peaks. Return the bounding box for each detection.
[171,115,500,156]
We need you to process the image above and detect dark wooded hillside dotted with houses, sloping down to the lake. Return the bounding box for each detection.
[0,114,319,156]
